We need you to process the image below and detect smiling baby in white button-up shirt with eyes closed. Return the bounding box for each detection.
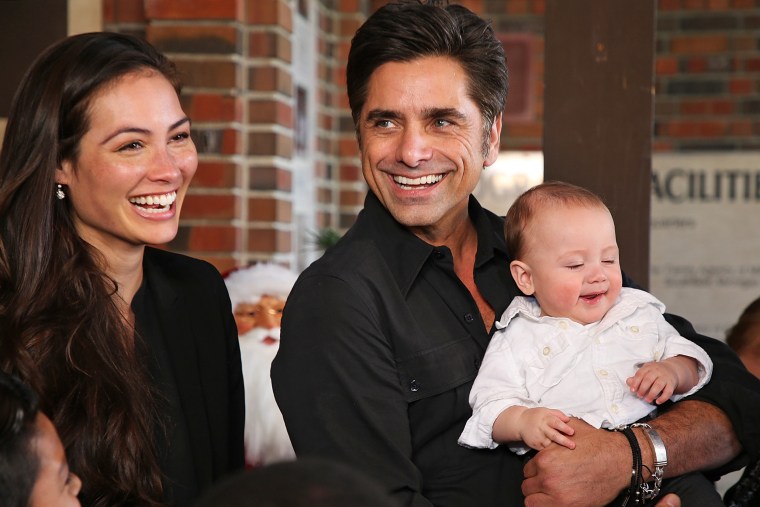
[459,182,719,505]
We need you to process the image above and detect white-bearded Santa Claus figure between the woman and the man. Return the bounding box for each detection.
[225,263,297,467]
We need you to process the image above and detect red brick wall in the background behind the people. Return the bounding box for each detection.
[104,0,760,271]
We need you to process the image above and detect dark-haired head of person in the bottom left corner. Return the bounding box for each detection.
[0,371,82,507]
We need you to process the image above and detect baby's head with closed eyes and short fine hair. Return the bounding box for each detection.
[504,182,623,324]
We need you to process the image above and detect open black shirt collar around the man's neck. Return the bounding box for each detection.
[356,191,507,295]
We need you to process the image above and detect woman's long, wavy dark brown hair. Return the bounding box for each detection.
[0,32,179,507]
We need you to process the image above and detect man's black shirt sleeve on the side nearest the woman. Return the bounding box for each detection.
[271,276,432,507]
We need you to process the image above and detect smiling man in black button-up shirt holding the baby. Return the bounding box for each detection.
[272,2,760,507]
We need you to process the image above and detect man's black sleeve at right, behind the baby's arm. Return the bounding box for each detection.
[623,275,760,475]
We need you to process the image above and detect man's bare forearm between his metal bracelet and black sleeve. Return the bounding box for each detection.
[634,400,741,479]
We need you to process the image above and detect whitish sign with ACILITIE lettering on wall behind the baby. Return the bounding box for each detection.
[649,152,760,339]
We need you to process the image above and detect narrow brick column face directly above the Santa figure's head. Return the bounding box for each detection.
[245,0,295,265]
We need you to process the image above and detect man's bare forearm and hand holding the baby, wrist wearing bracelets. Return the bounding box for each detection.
[522,400,741,507]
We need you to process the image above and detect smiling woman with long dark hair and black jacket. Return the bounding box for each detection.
[0,33,244,506]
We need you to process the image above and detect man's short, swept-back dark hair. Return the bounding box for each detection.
[346,0,509,132]
